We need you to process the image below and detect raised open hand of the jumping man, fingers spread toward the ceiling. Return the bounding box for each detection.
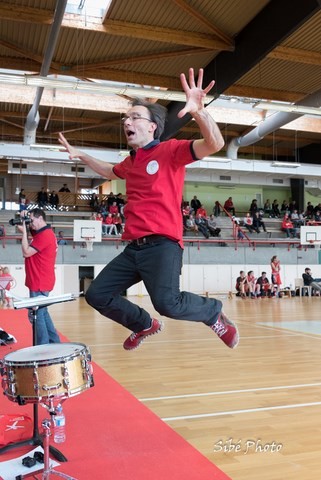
[177,68,215,118]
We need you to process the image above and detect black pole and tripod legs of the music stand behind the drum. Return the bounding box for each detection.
[0,306,67,462]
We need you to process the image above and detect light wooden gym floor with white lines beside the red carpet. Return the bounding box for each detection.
[50,297,321,480]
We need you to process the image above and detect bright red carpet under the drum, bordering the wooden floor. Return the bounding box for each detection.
[0,310,229,480]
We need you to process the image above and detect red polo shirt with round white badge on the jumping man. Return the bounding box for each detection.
[113,139,196,246]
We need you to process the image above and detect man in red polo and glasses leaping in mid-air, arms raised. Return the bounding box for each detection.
[59,68,239,350]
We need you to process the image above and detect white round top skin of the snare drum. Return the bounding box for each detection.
[4,343,87,364]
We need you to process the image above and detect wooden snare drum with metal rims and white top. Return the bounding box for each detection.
[1,343,93,405]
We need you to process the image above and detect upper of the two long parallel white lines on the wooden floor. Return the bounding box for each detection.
[139,382,321,402]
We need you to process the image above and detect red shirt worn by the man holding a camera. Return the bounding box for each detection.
[25,226,57,292]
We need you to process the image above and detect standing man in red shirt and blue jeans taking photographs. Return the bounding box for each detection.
[18,208,60,345]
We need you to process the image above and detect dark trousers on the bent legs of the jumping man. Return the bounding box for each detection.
[86,237,222,332]
